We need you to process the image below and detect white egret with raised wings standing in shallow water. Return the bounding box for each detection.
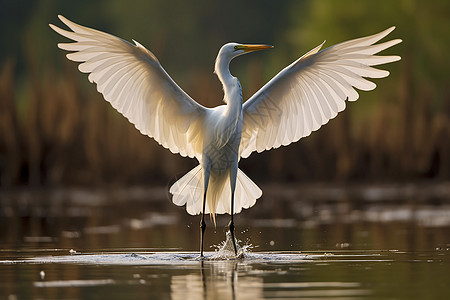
[50,16,401,256]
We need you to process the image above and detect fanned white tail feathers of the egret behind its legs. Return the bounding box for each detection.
[169,165,262,219]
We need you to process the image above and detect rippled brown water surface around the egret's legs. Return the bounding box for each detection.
[0,185,450,300]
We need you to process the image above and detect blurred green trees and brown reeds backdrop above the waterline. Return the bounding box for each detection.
[0,0,450,187]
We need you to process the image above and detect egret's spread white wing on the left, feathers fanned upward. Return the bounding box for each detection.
[50,16,207,157]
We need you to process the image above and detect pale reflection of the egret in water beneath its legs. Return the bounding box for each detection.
[170,254,371,300]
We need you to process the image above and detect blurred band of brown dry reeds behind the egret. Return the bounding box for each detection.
[0,53,450,186]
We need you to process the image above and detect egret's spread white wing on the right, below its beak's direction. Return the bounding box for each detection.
[240,27,401,158]
